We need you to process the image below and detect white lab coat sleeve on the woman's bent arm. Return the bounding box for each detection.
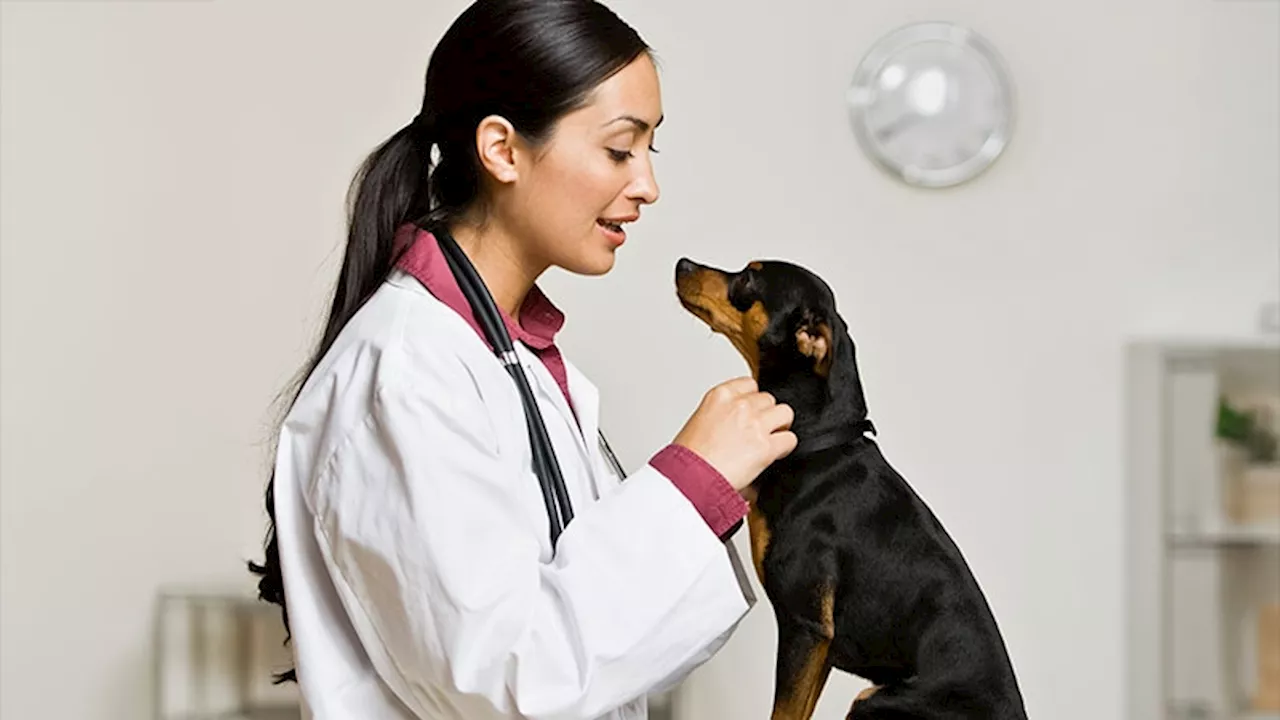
[310,351,754,720]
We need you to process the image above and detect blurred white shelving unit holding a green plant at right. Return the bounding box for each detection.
[1125,338,1280,720]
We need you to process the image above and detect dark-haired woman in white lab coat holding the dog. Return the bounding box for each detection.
[251,0,795,720]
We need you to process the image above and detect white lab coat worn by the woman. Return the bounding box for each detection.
[275,270,755,720]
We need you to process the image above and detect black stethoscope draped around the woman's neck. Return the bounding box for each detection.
[431,228,626,548]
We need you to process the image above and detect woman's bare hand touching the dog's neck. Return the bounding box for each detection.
[675,377,796,492]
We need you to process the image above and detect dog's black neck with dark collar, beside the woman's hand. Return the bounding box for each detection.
[759,324,874,456]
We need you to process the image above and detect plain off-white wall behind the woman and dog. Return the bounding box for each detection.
[0,0,1280,720]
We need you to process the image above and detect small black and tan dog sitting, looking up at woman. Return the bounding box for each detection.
[676,259,1027,720]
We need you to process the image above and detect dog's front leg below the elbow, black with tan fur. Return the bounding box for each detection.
[772,585,835,720]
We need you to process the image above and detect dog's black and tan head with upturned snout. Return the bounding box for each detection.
[676,258,849,387]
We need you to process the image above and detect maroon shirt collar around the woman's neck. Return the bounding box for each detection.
[396,224,564,350]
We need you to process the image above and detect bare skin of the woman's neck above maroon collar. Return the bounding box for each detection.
[449,223,547,323]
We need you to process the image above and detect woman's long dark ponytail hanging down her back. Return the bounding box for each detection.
[248,117,431,684]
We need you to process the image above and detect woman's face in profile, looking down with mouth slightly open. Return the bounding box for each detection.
[481,54,663,275]
